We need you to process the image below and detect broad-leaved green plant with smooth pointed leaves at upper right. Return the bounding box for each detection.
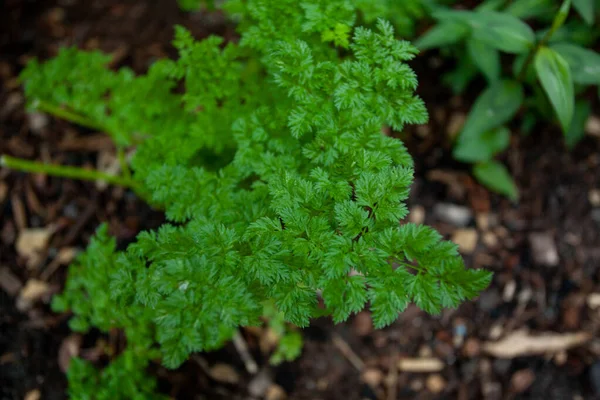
[416,0,600,199]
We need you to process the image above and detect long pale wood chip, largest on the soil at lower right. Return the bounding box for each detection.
[483,330,590,358]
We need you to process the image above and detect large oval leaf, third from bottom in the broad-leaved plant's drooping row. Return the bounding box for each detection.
[459,80,523,141]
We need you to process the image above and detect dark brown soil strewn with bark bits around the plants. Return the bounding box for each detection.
[0,0,600,400]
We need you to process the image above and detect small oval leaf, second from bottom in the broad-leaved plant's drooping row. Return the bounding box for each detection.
[452,126,510,163]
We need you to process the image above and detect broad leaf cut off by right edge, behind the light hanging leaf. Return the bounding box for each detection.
[550,43,600,85]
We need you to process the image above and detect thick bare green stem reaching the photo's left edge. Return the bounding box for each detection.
[0,156,137,190]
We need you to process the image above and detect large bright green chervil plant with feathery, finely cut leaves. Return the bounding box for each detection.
[3,0,491,399]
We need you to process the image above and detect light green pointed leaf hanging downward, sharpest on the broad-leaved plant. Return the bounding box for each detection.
[535,47,575,132]
